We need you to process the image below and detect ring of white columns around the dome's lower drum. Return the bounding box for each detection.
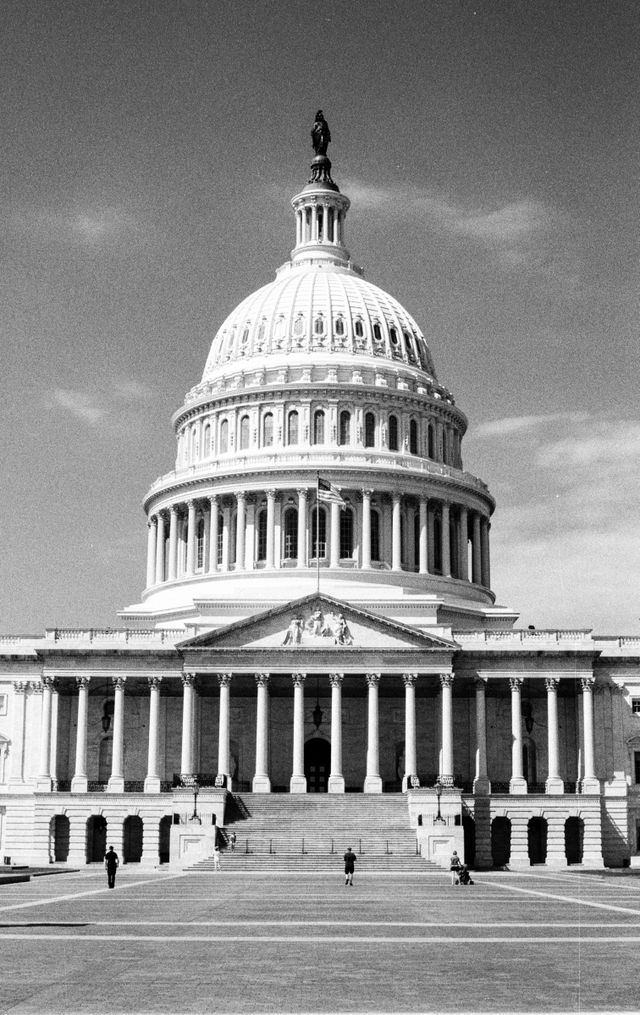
[147,488,491,588]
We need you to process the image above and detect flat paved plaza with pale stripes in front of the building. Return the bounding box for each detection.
[0,865,640,1015]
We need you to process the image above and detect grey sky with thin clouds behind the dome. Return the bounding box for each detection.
[0,0,640,634]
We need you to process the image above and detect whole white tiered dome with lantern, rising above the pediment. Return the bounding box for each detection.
[122,125,500,629]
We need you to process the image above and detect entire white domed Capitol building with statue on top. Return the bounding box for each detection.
[0,116,640,868]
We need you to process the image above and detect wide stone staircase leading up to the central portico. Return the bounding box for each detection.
[192,793,438,873]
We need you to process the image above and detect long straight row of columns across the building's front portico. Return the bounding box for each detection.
[28,673,599,794]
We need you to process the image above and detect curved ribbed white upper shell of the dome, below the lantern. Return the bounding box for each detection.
[202,264,436,383]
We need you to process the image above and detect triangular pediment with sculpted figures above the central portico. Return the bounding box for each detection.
[177,595,456,652]
